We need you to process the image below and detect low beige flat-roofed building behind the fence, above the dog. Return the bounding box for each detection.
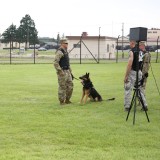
[66,32,116,59]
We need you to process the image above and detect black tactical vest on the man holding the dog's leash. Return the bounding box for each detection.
[58,48,69,70]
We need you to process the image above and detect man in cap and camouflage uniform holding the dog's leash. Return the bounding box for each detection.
[54,39,73,105]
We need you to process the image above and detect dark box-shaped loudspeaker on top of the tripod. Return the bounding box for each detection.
[129,27,147,41]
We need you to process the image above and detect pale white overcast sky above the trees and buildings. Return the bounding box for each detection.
[0,0,160,38]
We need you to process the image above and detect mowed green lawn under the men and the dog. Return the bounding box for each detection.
[0,62,160,160]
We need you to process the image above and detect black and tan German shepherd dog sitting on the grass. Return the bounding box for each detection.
[79,73,102,104]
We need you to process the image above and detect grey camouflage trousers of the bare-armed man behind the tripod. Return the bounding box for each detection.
[124,70,147,108]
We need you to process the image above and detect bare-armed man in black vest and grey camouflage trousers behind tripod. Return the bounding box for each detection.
[124,40,148,111]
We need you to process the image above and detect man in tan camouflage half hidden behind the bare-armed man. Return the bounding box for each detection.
[139,42,151,94]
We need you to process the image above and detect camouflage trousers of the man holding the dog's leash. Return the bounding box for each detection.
[57,70,73,102]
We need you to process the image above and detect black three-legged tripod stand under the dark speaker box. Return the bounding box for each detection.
[126,41,150,124]
